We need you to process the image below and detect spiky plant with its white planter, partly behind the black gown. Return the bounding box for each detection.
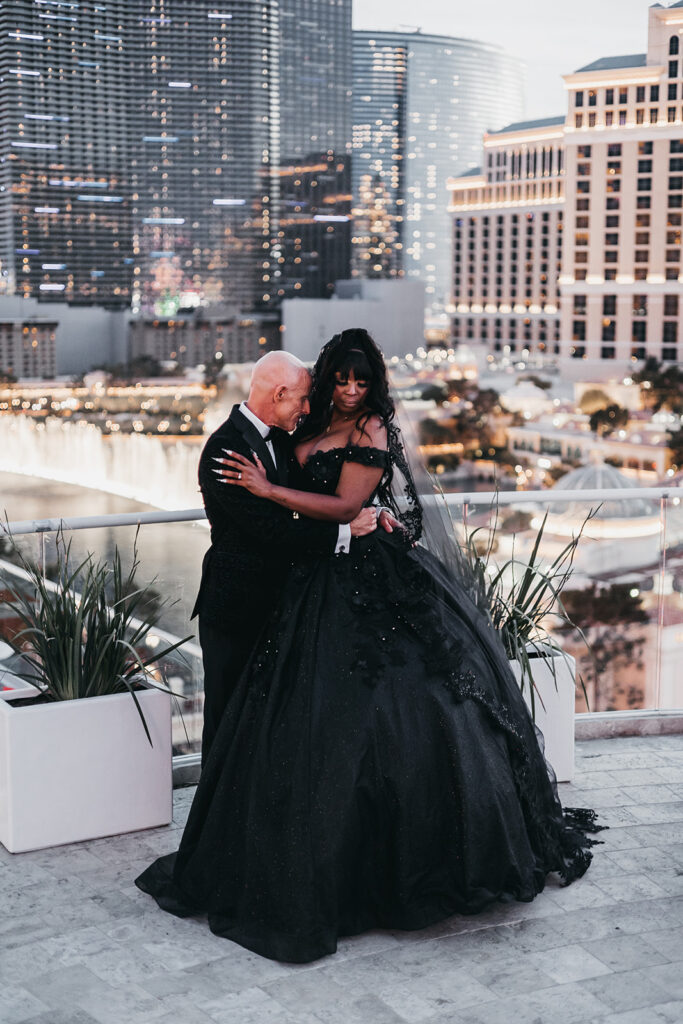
[454,512,595,782]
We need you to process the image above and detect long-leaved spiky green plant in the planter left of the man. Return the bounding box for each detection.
[0,527,191,745]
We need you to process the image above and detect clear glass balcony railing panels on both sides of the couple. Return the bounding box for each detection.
[0,488,683,762]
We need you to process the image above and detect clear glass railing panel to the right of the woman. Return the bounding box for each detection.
[445,488,683,714]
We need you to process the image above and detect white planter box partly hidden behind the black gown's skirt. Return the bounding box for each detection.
[510,654,577,782]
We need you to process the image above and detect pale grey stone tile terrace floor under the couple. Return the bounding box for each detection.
[0,736,683,1024]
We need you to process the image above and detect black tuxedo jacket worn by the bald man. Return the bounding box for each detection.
[193,406,339,632]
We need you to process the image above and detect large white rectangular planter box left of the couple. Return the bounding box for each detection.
[0,688,173,853]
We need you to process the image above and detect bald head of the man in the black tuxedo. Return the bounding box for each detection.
[247,352,310,431]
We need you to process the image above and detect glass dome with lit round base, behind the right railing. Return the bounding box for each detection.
[539,454,659,538]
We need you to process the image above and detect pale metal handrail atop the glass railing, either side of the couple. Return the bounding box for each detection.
[0,487,683,537]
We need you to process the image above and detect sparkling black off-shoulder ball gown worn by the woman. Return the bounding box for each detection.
[136,446,597,963]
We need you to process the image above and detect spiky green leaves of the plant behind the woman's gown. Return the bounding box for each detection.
[461,509,597,718]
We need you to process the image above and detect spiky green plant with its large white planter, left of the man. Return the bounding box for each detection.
[0,535,189,853]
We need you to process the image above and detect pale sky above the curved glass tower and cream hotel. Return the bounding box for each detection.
[353,0,655,118]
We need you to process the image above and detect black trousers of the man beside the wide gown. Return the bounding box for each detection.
[199,614,262,767]
